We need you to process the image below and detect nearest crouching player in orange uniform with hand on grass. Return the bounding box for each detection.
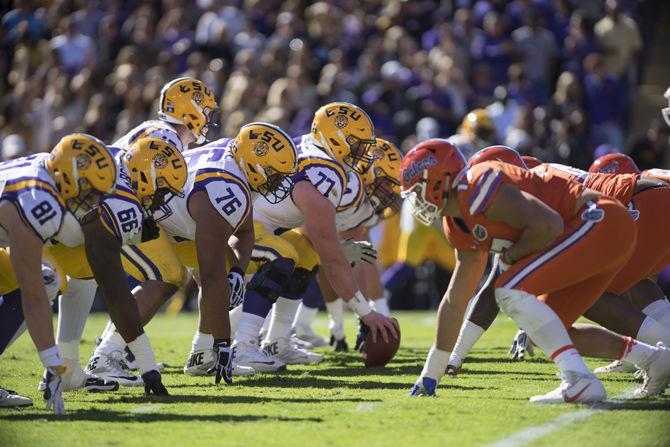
[402,140,670,403]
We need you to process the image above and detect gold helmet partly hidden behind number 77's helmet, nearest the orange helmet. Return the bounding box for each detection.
[362,138,402,218]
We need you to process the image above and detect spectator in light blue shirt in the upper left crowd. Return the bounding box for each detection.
[51,16,96,76]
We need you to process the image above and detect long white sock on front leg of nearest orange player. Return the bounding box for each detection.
[495,288,591,375]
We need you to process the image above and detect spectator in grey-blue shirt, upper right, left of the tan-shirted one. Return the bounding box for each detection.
[512,8,558,102]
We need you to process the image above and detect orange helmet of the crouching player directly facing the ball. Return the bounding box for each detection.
[400,138,466,225]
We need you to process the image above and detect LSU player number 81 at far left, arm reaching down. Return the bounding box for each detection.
[0,134,117,414]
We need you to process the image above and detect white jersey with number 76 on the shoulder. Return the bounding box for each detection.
[159,138,252,241]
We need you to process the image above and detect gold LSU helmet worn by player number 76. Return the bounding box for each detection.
[231,122,298,203]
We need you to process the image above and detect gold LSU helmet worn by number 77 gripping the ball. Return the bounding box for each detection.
[311,102,375,174]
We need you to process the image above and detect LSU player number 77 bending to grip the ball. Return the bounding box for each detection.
[235,103,397,367]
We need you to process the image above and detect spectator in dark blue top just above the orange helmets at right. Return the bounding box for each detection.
[584,54,626,147]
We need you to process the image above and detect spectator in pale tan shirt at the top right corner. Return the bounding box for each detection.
[595,0,642,83]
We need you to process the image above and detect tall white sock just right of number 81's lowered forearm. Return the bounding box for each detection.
[56,279,98,363]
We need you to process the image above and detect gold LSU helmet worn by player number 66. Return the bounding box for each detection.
[124,138,188,221]
